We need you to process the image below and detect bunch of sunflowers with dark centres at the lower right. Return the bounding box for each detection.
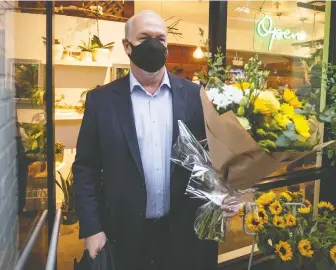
[239,191,336,270]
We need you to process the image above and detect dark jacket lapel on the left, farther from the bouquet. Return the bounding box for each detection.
[112,76,145,179]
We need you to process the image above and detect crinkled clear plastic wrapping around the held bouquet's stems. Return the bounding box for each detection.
[172,121,254,242]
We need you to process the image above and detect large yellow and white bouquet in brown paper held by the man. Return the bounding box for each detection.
[172,54,331,241]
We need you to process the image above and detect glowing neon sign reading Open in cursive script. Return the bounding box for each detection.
[257,16,307,51]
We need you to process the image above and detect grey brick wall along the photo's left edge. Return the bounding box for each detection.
[0,4,18,269]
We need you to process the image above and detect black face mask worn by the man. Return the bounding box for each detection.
[128,38,168,72]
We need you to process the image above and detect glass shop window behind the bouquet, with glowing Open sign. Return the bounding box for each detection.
[219,1,325,261]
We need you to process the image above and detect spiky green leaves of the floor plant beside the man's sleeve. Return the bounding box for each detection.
[55,170,75,212]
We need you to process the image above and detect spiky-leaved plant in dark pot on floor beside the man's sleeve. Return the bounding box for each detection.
[56,171,78,225]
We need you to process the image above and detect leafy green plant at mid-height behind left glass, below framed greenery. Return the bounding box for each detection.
[19,122,47,160]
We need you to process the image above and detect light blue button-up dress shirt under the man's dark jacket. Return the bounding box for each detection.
[130,71,173,219]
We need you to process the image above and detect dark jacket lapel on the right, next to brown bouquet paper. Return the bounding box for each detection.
[169,74,186,173]
